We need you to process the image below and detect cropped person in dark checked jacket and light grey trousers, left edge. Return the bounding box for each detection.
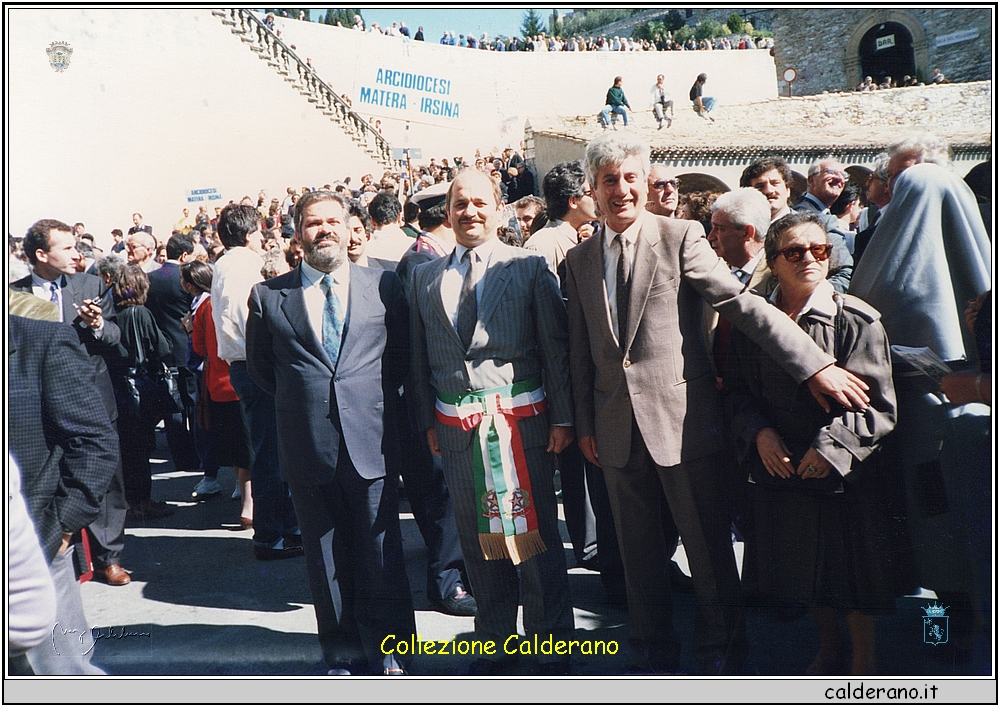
[7,316,120,675]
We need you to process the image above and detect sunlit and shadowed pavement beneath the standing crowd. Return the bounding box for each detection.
[82,434,991,677]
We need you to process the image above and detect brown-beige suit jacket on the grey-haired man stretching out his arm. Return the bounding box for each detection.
[566,212,833,468]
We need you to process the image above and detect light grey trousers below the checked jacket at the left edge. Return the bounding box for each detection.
[26,546,105,675]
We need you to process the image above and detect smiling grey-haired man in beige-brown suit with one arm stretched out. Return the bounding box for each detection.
[566,133,868,673]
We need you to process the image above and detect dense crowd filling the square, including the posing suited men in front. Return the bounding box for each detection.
[8,131,992,675]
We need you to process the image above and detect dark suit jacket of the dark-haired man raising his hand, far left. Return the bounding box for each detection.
[10,273,121,420]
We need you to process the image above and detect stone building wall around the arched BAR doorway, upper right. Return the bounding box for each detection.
[772,8,993,95]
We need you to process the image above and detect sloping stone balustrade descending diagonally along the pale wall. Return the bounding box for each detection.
[212,8,401,172]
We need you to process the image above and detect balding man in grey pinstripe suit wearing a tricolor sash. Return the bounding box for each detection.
[408,170,573,674]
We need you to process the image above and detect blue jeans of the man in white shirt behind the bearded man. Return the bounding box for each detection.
[229,361,299,547]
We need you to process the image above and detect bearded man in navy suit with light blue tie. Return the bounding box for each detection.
[246,191,416,675]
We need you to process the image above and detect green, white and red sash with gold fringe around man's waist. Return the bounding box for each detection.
[435,379,548,565]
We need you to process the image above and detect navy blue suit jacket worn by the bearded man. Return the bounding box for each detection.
[246,263,409,485]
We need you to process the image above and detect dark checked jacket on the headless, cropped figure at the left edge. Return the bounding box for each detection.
[7,316,118,562]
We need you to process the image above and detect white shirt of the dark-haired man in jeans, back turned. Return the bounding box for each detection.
[212,246,264,364]
